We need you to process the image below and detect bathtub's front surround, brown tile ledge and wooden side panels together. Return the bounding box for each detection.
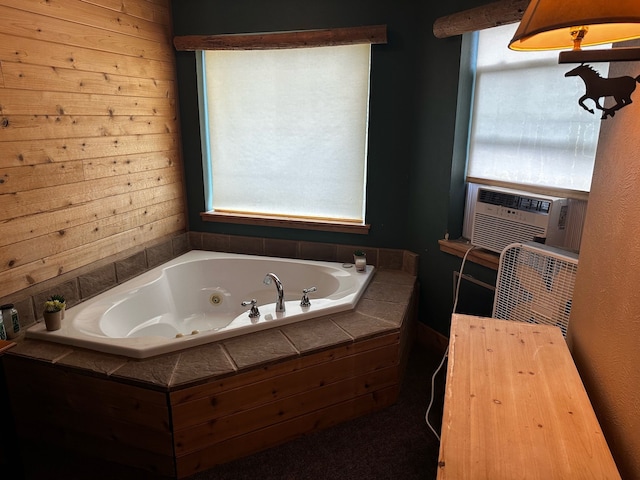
[4,239,417,478]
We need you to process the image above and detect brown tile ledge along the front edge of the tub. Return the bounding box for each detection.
[7,269,416,391]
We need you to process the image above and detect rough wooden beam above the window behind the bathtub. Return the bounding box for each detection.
[173,25,387,51]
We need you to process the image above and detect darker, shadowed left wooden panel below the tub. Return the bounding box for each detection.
[3,356,174,476]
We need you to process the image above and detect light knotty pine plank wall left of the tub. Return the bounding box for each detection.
[0,0,186,297]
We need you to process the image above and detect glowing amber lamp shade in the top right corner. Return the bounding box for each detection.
[509,0,640,50]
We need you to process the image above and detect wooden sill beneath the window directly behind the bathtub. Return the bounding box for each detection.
[200,212,371,235]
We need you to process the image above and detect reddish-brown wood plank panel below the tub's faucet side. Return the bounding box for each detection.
[171,333,402,478]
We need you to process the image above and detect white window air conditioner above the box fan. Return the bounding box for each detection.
[471,187,568,253]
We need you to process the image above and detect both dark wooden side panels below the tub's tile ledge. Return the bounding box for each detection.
[4,316,414,478]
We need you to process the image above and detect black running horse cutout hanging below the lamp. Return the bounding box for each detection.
[564,64,640,120]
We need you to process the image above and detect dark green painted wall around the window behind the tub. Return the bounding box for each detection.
[172,0,492,334]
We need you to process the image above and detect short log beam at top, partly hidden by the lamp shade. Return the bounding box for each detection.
[433,0,529,38]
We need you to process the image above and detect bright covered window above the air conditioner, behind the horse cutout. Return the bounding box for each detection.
[467,23,608,193]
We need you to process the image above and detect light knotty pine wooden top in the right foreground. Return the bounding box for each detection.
[438,314,620,480]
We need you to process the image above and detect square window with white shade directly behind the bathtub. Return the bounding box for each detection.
[199,44,371,231]
